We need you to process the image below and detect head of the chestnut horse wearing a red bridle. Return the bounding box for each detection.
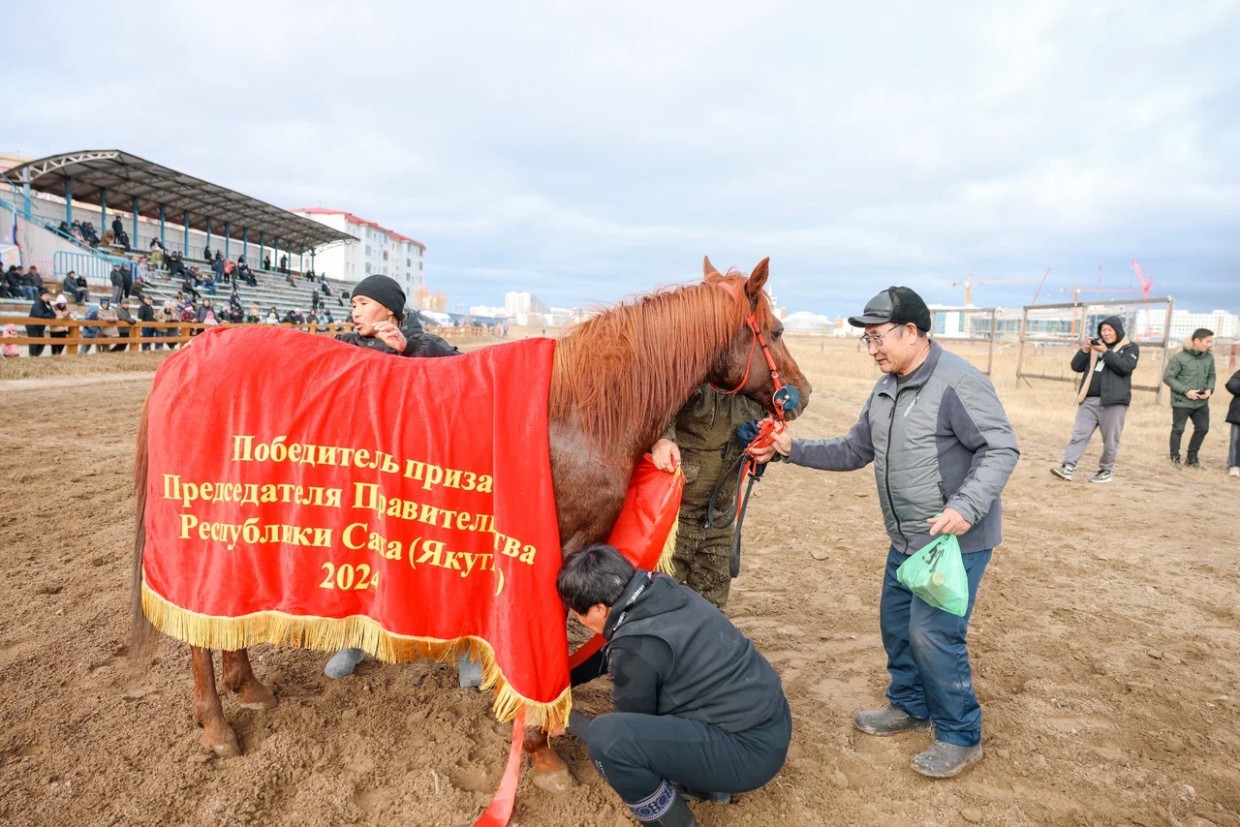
[703,258,813,419]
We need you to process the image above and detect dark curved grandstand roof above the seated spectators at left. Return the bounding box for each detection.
[4,149,357,253]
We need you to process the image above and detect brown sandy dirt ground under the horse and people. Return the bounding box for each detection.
[0,340,1240,827]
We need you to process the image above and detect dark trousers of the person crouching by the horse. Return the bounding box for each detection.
[587,701,792,805]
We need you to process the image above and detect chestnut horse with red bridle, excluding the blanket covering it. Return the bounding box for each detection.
[130,259,811,790]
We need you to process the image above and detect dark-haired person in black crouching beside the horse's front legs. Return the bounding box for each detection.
[552,544,792,827]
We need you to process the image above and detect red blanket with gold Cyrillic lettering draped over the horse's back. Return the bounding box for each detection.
[143,327,570,724]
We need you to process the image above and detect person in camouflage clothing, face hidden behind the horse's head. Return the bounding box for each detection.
[650,384,766,609]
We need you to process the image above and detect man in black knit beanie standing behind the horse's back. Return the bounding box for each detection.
[324,274,466,687]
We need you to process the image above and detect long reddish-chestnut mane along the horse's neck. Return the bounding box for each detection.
[551,272,748,446]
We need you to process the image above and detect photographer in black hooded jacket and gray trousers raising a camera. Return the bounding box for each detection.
[1050,316,1141,482]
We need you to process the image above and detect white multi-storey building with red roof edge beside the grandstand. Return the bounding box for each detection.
[289,207,427,300]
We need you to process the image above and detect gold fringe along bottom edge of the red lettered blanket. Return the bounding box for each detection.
[143,583,573,729]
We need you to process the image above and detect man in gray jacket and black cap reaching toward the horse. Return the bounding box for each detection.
[755,286,1019,779]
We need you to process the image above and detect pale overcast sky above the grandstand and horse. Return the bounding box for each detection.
[0,0,1240,315]
